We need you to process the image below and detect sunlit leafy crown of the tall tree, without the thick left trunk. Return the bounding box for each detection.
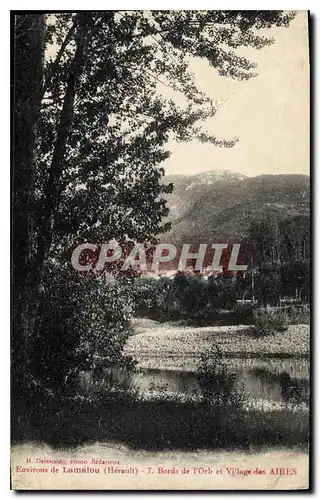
[38,11,296,252]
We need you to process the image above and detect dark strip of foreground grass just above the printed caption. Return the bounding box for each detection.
[12,398,309,450]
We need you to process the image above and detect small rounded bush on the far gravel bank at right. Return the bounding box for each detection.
[253,306,288,336]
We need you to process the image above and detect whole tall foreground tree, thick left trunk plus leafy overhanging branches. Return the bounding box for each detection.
[14,11,294,390]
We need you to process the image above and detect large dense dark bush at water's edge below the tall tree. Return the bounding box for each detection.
[31,266,138,392]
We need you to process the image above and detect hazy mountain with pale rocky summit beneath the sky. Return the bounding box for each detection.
[162,171,310,243]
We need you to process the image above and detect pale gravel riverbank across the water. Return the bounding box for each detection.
[125,319,310,371]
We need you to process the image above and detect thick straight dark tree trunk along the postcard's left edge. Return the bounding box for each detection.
[11,14,45,386]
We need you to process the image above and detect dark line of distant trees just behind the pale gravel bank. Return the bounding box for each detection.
[134,261,309,324]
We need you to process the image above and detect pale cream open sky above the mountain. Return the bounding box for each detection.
[162,11,309,180]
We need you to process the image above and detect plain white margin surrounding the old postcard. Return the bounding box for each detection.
[0,0,320,499]
